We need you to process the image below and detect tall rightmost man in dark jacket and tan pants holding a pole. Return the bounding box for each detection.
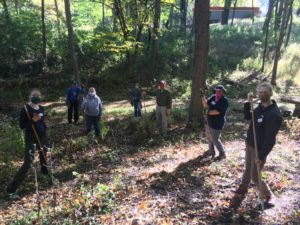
[237,82,283,202]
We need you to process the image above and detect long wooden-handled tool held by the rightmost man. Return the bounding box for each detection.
[250,96,264,212]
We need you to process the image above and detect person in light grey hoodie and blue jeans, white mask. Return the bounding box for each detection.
[81,87,103,137]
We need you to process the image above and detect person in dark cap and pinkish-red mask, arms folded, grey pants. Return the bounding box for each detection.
[203,85,229,160]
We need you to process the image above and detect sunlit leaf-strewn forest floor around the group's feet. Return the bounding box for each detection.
[0,97,300,225]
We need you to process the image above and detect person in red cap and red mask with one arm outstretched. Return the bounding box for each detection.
[147,80,172,137]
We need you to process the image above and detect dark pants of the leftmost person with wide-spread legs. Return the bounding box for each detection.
[7,135,48,193]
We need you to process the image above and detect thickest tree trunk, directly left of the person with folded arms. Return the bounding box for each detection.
[188,0,210,126]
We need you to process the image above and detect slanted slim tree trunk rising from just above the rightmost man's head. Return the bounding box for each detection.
[271,0,290,85]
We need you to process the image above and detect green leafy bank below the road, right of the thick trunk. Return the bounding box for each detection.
[208,23,262,79]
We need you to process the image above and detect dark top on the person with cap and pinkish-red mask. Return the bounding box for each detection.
[207,95,228,130]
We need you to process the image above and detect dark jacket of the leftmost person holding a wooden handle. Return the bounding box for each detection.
[19,104,47,137]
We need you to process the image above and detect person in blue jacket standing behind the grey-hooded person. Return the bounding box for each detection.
[66,82,84,123]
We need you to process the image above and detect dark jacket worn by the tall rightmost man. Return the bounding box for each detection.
[244,100,283,161]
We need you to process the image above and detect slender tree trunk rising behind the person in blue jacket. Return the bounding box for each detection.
[64,0,80,83]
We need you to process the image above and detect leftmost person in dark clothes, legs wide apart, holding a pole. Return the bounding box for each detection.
[6,89,48,194]
